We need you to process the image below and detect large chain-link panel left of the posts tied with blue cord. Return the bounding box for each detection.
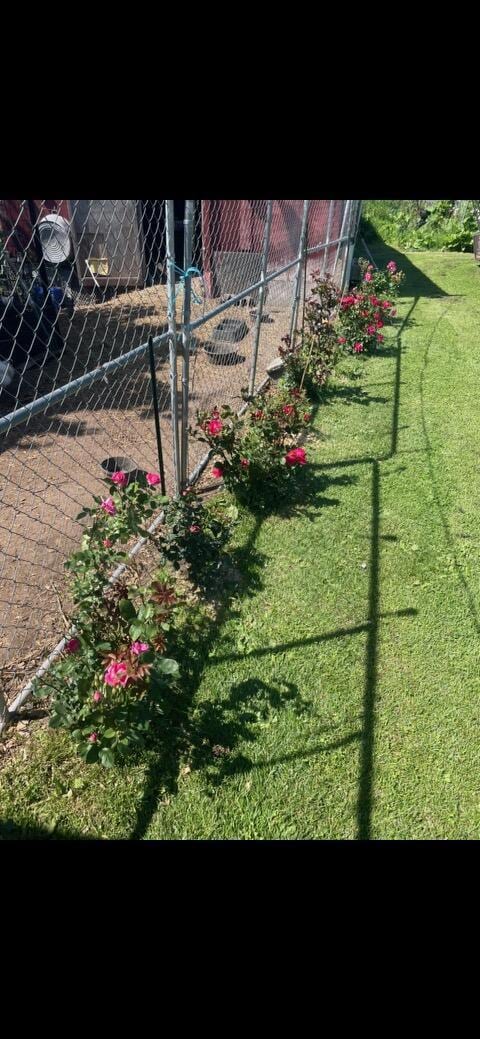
[0,199,172,706]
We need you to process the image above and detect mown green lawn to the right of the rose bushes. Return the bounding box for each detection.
[0,249,480,841]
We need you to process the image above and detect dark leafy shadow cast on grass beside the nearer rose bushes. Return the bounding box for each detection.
[130,461,352,841]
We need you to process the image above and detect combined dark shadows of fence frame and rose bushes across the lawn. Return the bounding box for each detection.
[131,249,445,841]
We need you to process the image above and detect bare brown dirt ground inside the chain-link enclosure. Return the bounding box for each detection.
[0,279,291,698]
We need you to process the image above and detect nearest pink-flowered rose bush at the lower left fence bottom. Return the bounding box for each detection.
[34,565,181,767]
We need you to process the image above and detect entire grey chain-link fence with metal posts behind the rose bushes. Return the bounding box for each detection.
[0,198,361,723]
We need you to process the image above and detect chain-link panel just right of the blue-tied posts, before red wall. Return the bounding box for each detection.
[181,198,303,470]
